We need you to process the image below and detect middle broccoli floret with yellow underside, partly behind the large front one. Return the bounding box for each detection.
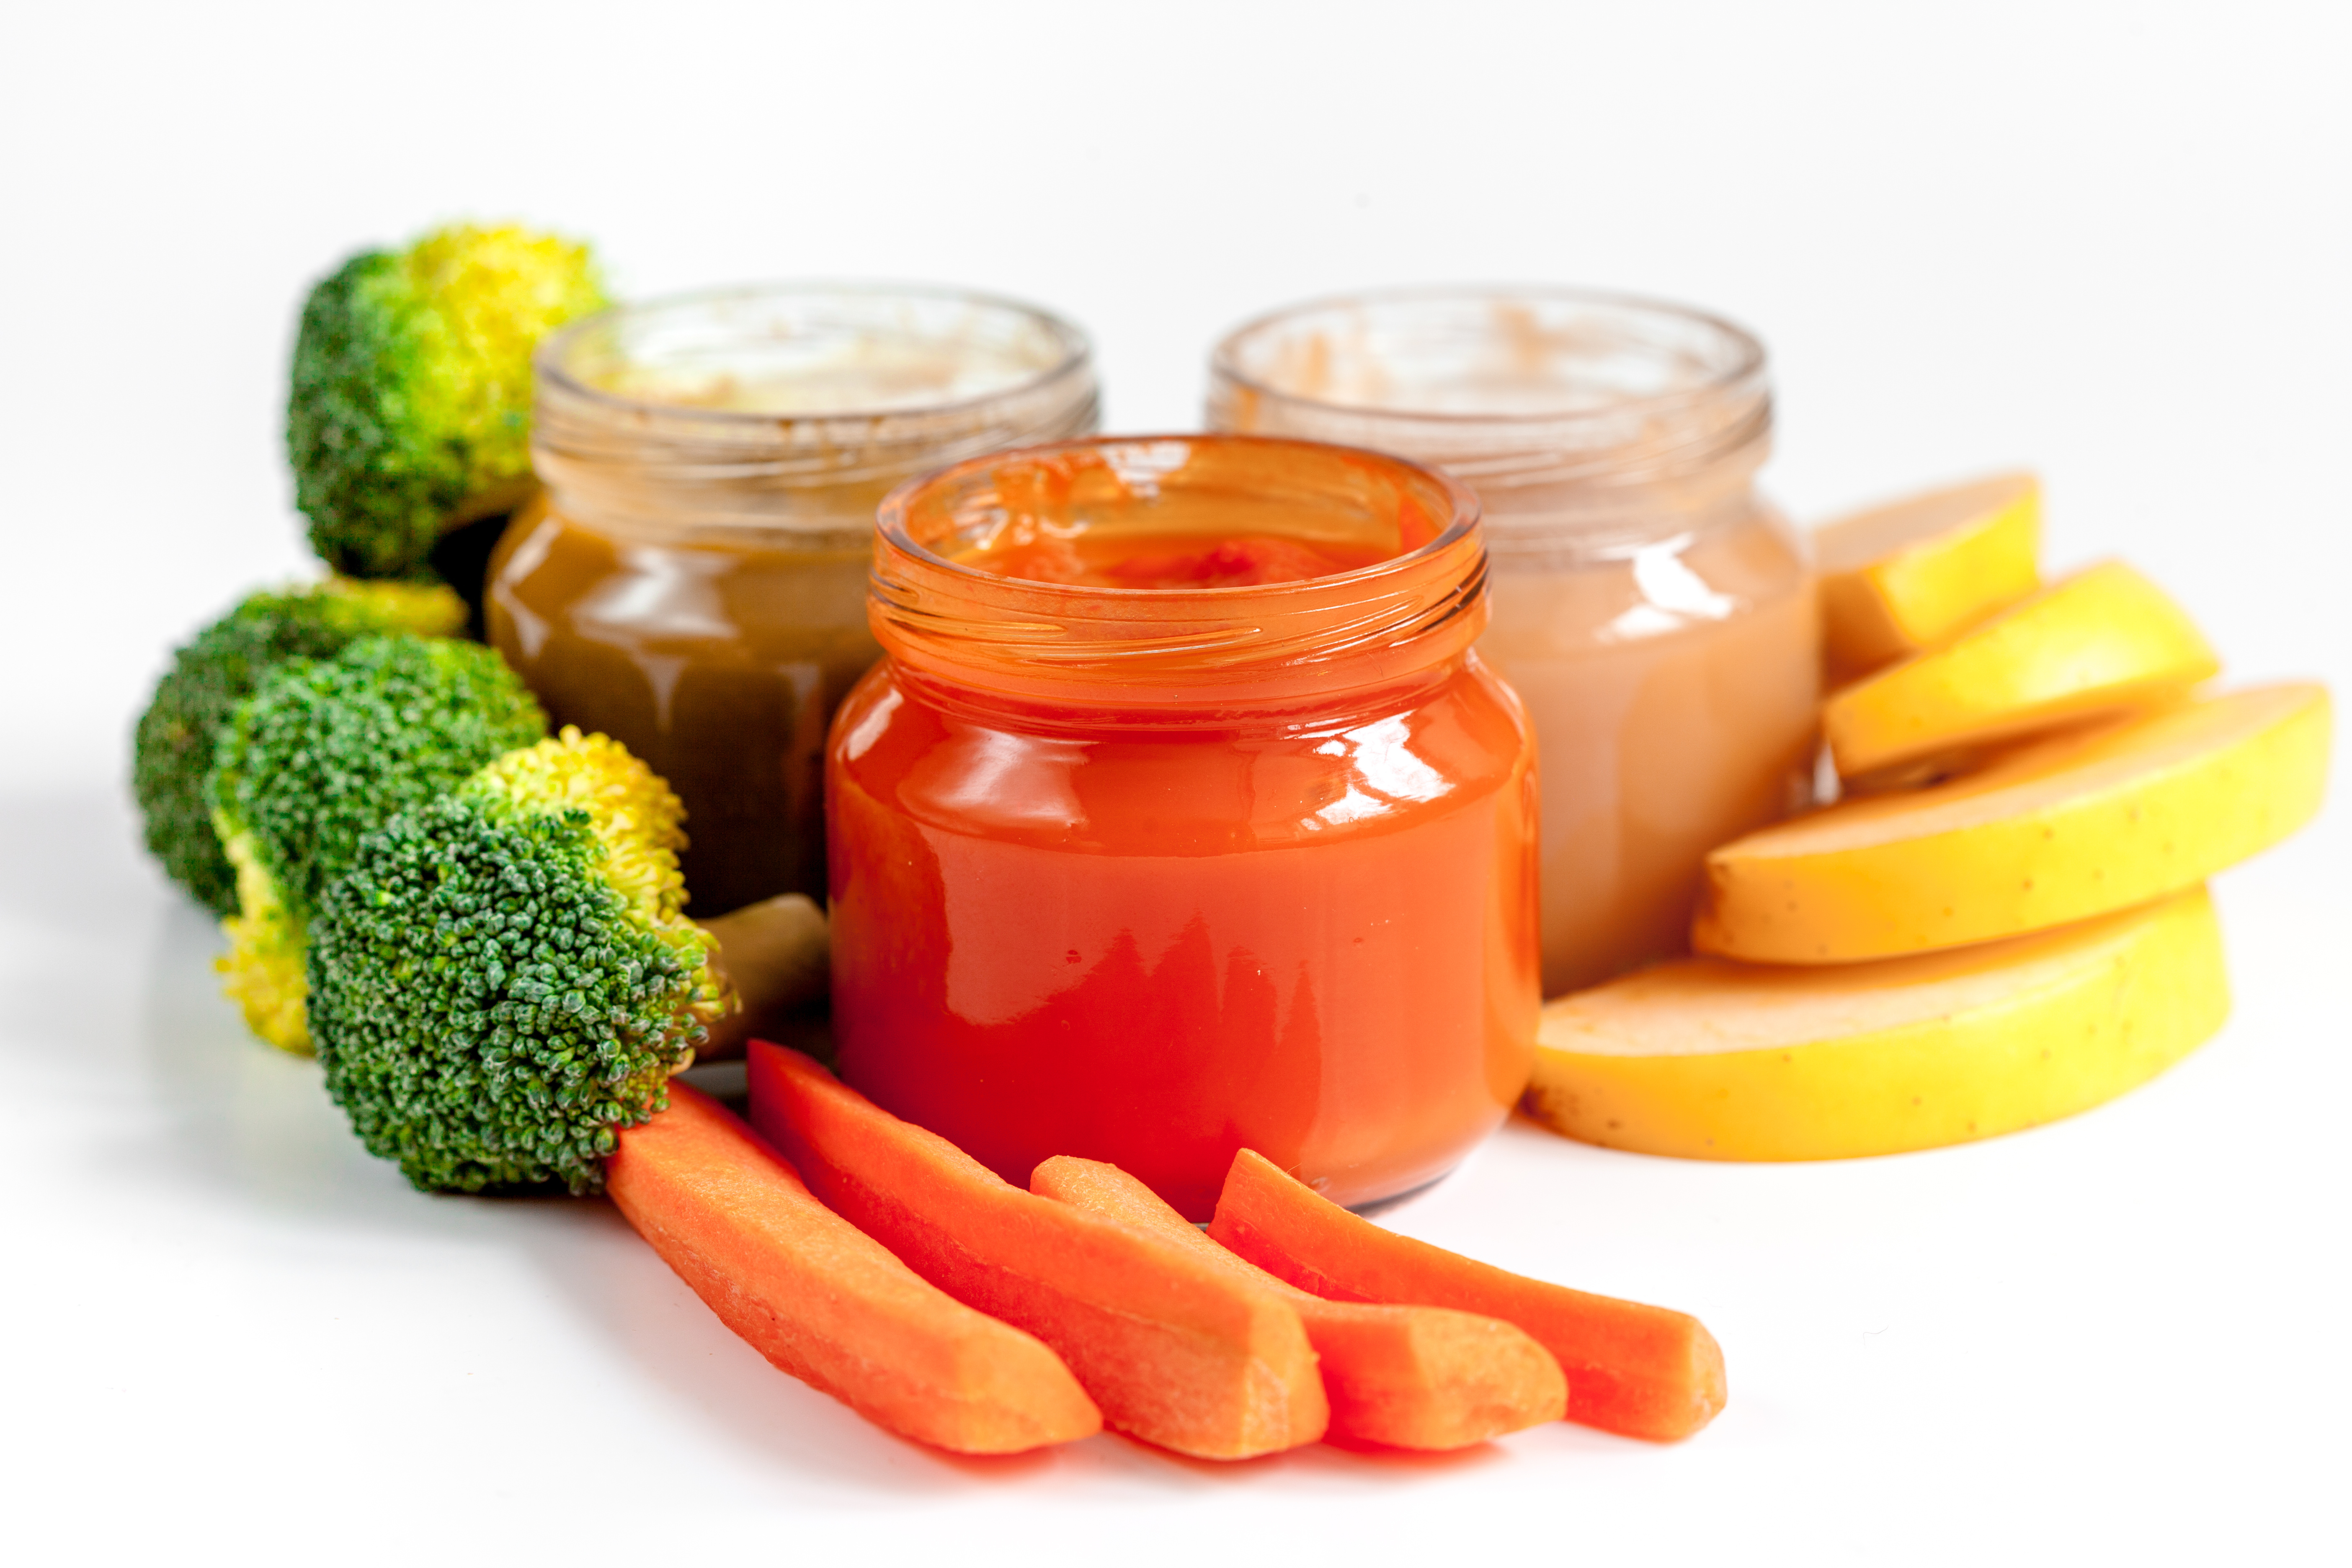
[209,637,548,1051]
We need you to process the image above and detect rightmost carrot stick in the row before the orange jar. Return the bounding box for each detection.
[1209,1150,1724,1441]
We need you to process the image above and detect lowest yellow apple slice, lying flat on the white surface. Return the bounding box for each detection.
[1527,889,2230,1159]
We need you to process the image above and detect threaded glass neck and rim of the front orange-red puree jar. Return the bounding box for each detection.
[870,435,1486,708]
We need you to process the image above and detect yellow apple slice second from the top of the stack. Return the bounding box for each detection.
[1821,562,2220,778]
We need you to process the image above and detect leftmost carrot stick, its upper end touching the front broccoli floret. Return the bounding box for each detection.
[604,1084,1103,1453]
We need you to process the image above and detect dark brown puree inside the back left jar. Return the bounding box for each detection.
[487,498,882,915]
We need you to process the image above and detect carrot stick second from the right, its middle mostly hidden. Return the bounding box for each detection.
[1030,1154,1569,1450]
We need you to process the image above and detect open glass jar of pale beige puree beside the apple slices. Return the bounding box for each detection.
[1209,289,1821,994]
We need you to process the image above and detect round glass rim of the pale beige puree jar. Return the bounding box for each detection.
[1209,282,1767,430]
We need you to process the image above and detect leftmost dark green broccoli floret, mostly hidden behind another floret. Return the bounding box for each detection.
[132,578,466,915]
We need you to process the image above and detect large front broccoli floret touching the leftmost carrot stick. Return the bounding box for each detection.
[308,729,734,1192]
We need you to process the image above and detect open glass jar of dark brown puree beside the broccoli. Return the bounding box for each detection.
[487,284,1096,917]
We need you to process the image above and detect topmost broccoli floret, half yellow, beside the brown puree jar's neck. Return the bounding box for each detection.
[287,223,607,578]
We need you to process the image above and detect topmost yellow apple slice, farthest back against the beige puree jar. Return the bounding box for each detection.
[1813,472,2042,677]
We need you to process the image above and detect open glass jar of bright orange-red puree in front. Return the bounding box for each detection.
[825,437,1538,1220]
